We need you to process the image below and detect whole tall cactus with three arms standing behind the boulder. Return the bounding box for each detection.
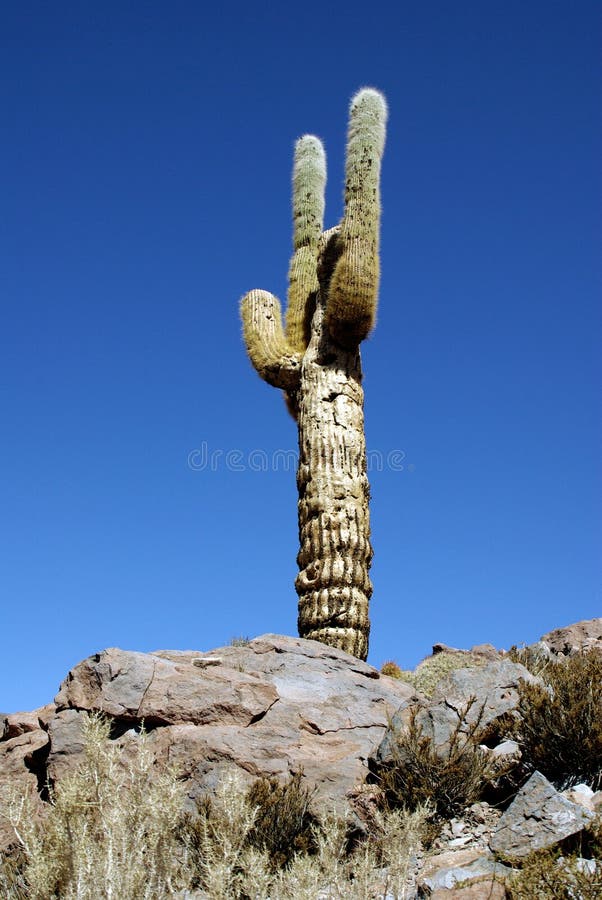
[241,88,387,659]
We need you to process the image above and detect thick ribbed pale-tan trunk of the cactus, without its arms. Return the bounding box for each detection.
[295,243,372,659]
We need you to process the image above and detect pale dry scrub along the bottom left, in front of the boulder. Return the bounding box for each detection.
[0,716,426,900]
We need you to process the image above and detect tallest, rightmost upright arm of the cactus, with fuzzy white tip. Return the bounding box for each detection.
[326,88,387,349]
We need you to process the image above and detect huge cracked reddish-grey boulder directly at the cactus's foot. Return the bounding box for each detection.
[8,635,417,824]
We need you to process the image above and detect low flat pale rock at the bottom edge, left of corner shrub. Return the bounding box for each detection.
[418,849,512,898]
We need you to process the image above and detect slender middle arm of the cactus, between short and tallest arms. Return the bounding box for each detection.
[286,134,326,353]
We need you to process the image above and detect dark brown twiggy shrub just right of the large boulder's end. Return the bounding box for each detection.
[375,699,498,818]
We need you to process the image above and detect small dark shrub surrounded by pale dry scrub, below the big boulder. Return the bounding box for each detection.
[246,772,316,868]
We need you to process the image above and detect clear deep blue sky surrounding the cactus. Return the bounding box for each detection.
[0,0,602,711]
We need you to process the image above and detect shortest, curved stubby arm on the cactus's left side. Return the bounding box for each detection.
[240,290,301,392]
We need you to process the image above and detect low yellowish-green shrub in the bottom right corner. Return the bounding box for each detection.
[506,850,602,900]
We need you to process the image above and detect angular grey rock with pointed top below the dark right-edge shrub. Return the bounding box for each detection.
[489,772,594,861]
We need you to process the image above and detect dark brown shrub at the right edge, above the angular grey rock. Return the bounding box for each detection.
[514,651,602,790]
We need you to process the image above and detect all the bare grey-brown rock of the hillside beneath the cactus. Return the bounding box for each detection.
[0,619,602,900]
